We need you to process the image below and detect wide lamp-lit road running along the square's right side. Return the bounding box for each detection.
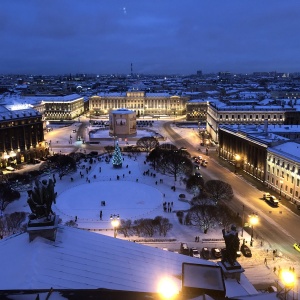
[163,122,300,261]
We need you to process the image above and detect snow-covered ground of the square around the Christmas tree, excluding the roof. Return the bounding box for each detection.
[5,116,300,290]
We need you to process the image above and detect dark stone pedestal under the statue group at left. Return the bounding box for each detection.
[27,215,59,242]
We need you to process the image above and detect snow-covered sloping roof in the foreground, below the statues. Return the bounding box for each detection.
[0,226,258,297]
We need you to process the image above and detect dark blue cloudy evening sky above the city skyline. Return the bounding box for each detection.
[0,0,300,74]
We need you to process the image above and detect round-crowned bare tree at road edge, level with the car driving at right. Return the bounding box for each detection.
[204,180,233,203]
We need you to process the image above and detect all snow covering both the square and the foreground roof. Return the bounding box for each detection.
[0,116,300,293]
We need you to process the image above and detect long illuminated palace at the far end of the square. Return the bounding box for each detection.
[89,91,189,117]
